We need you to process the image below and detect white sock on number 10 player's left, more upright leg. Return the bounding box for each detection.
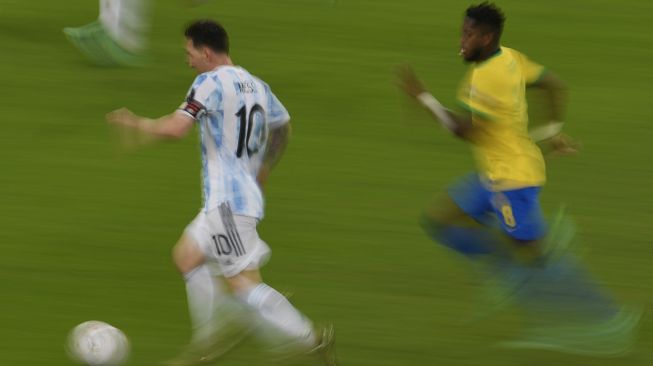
[184,265,231,341]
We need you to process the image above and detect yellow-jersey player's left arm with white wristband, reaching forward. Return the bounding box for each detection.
[399,65,474,140]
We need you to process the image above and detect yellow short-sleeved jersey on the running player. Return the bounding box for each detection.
[458,47,546,190]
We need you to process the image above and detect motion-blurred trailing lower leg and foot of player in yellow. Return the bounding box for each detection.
[500,210,643,357]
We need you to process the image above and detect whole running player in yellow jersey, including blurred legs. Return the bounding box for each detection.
[400,3,639,355]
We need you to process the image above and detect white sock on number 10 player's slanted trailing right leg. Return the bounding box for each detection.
[237,283,316,346]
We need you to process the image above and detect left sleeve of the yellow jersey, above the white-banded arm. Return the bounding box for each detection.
[458,70,505,121]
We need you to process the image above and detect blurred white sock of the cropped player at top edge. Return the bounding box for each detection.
[100,0,149,53]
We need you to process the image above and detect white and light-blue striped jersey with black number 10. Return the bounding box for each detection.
[180,66,290,219]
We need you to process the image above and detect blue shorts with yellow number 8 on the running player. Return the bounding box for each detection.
[448,173,546,241]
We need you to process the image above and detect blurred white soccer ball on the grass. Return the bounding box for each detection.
[68,320,129,366]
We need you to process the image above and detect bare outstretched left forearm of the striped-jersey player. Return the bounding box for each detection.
[106,108,195,139]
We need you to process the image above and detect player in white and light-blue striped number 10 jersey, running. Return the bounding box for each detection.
[107,20,336,365]
